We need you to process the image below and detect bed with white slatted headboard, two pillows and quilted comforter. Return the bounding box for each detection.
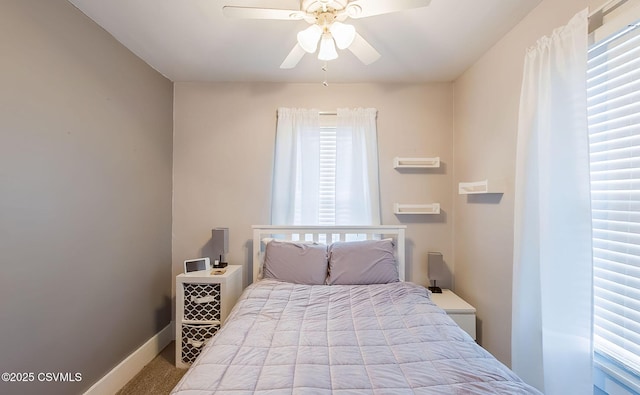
[172,226,539,395]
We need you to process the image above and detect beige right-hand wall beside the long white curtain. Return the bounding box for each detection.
[453,0,602,364]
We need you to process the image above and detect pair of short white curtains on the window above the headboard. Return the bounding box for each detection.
[271,108,380,225]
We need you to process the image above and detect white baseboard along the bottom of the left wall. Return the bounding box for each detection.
[84,321,175,395]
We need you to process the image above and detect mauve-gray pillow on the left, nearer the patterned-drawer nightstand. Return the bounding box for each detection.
[263,240,328,285]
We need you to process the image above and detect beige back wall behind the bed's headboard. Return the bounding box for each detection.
[173,83,453,290]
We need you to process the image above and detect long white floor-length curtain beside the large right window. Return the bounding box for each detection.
[512,10,593,395]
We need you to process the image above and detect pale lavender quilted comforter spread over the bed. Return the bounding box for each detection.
[173,280,539,395]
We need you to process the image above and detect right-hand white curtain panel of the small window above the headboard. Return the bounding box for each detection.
[336,108,380,225]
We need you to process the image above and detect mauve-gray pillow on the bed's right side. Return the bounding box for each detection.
[327,239,399,285]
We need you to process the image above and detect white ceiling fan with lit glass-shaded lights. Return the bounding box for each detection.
[222,0,431,69]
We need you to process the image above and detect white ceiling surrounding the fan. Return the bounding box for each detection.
[69,0,541,82]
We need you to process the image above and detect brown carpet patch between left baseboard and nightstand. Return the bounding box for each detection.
[116,342,187,395]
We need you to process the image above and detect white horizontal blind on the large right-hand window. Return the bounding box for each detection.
[587,19,640,374]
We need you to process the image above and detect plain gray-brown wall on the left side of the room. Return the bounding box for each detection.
[0,0,173,394]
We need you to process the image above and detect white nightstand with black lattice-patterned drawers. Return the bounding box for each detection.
[176,265,242,368]
